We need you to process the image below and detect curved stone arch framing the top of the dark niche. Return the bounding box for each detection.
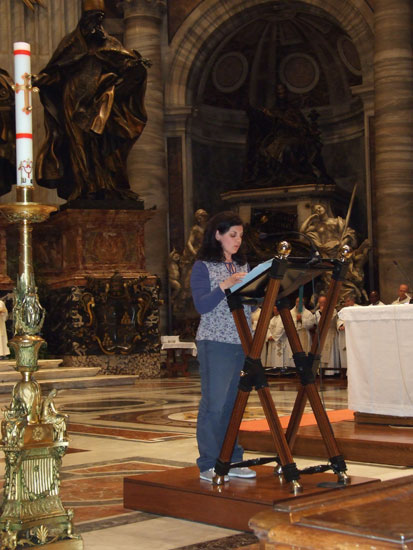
[165,0,373,110]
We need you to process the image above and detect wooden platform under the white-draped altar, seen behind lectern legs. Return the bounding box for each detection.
[239,420,413,466]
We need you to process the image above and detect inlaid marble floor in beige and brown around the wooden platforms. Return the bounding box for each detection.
[0,370,413,550]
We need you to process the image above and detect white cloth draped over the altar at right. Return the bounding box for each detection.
[339,304,413,417]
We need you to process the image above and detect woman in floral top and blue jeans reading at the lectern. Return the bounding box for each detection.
[191,211,256,483]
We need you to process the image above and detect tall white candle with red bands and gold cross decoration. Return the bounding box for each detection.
[13,42,33,187]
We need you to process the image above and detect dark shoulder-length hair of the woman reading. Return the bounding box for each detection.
[197,210,247,265]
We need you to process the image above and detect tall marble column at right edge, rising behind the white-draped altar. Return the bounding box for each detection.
[373,0,413,303]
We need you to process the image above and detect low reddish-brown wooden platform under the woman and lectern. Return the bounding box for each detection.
[123,466,380,531]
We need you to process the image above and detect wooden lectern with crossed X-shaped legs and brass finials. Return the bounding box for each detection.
[214,241,351,494]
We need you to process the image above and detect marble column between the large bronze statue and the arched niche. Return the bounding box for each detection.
[121,0,168,310]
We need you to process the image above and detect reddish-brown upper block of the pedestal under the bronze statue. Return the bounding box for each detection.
[34,209,153,288]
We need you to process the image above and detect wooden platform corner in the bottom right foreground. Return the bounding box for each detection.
[250,476,413,550]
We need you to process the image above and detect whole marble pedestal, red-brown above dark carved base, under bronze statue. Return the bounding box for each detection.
[20,209,160,377]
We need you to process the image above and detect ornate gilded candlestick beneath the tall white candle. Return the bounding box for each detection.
[0,188,83,550]
